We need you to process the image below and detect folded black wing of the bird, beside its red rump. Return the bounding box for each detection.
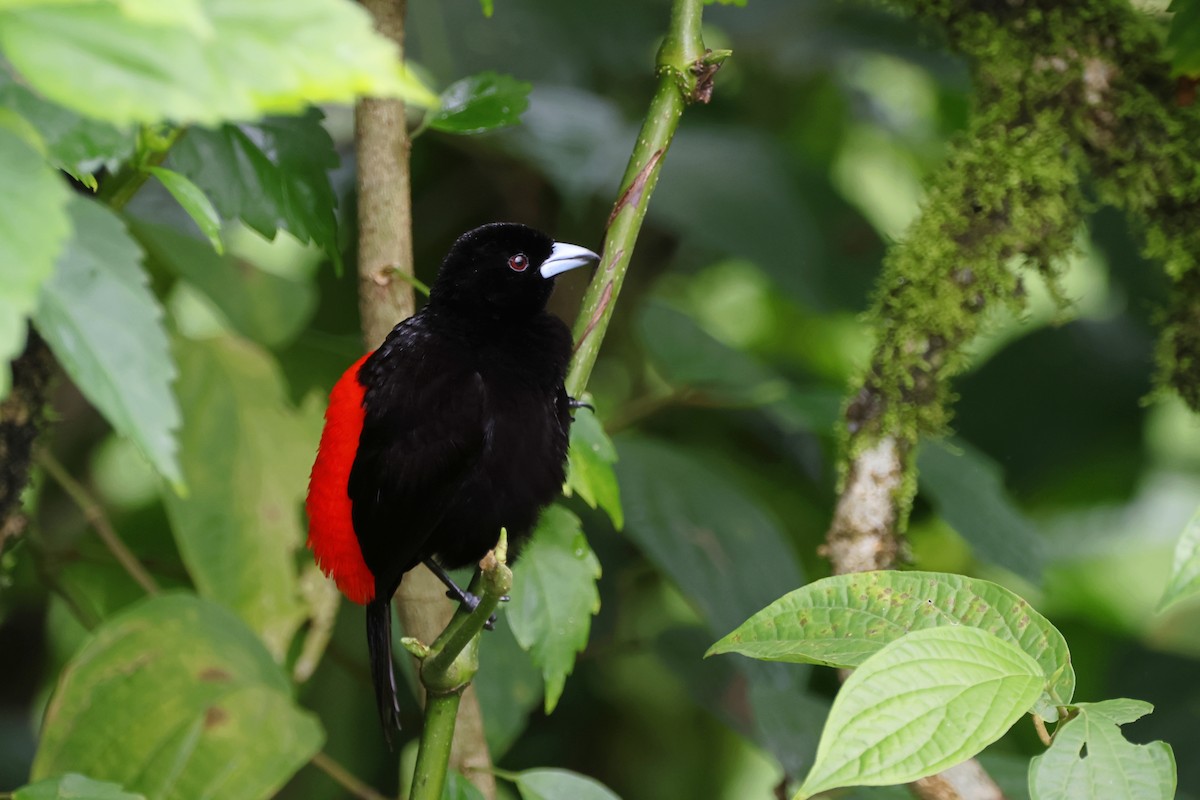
[348,337,487,594]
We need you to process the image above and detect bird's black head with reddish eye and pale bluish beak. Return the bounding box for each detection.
[430,222,600,318]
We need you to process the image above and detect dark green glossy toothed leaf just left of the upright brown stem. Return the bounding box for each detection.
[170,108,341,265]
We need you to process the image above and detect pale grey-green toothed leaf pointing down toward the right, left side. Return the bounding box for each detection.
[34,197,182,487]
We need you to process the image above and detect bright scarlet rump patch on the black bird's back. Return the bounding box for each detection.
[305,353,374,604]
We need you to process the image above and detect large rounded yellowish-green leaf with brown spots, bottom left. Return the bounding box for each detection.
[32,594,324,800]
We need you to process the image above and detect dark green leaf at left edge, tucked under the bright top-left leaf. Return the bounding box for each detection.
[0,71,134,191]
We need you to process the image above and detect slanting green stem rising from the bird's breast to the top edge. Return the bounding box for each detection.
[566,0,728,397]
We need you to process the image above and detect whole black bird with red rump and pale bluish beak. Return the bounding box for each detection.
[306,223,599,734]
